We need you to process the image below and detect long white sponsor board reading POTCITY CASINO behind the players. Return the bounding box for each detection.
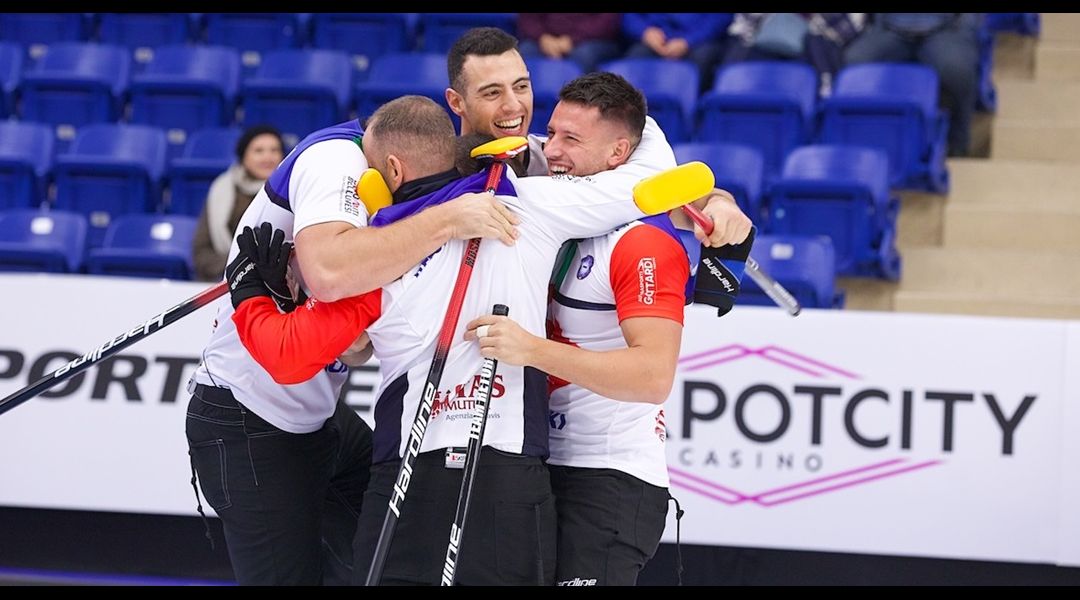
[0,275,1080,564]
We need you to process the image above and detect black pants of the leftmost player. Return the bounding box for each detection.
[187,385,372,585]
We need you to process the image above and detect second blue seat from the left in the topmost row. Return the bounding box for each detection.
[97,13,192,64]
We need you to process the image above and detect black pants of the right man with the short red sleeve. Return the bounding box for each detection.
[549,465,667,586]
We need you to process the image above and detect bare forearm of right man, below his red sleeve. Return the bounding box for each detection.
[530,338,675,405]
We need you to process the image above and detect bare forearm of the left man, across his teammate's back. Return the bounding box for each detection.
[296,205,453,302]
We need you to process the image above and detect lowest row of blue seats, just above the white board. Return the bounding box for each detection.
[0,205,843,308]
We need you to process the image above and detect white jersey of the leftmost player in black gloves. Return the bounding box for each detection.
[196,127,367,434]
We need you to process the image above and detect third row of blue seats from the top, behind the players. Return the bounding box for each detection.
[0,111,900,278]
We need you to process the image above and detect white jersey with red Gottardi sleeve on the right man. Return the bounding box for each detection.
[548,221,690,488]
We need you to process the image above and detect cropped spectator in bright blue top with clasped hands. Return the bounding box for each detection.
[622,13,731,91]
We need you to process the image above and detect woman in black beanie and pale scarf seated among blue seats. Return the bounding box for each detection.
[192,125,285,282]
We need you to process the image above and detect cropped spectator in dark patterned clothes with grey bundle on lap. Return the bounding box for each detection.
[724,13,866,96]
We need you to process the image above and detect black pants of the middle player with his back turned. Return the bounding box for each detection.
[353,448,555,585]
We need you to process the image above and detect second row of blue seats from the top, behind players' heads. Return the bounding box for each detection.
[0,44,948,192]
